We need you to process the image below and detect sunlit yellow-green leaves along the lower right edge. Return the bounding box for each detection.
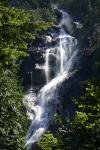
[73,78,100,149]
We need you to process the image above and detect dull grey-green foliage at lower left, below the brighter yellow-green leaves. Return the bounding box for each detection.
[0,70,27,150]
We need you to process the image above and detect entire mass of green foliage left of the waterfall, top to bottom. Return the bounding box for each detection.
[0,1,52,150]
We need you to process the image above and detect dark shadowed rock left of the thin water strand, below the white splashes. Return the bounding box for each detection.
[20,52,45,88]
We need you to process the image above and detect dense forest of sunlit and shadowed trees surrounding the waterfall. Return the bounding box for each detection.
[0,0,100,150]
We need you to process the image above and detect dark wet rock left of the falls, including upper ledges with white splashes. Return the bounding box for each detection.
[20,27,59,89]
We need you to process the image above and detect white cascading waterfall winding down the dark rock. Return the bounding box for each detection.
[26,12,78,145]
